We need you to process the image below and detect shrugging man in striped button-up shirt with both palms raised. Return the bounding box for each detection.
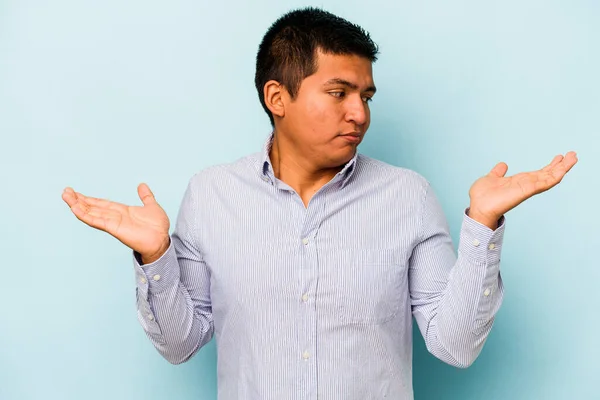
[63,8,577,400]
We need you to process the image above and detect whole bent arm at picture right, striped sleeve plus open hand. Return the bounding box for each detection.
[409,152,577,367]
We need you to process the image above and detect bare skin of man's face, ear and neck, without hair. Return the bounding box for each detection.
[264,51,376,206]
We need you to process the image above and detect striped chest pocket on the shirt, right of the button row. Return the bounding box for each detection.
[337,250,408,325]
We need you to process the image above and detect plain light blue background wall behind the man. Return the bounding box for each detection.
[0,0,600,400]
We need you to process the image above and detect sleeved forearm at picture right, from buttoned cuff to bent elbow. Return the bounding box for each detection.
[415,217,504,368]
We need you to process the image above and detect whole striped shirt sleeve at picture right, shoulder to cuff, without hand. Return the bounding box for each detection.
[409,186,505,368]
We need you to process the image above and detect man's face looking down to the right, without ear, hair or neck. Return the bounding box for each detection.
[276,51,375,168]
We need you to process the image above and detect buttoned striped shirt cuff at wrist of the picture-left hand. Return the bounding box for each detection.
[133,241,179,297]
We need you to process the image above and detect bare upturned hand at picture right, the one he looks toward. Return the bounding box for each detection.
[469,151,577,230]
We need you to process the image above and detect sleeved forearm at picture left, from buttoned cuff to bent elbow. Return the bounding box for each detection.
[134,245,213,364]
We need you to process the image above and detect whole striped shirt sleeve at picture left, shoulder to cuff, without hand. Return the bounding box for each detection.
[133,180,214,364]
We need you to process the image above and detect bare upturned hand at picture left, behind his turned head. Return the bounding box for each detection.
[62,183,170,264]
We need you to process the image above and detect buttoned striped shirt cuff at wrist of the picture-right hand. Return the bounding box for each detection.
[458,209,505,265]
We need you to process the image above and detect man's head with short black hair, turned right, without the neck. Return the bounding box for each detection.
[255,8,378,168]
